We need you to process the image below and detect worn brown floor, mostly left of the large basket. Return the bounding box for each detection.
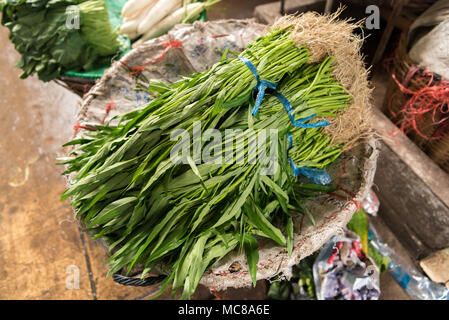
[0,0,412,299]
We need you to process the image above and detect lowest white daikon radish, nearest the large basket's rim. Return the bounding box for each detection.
[138,2,206,40]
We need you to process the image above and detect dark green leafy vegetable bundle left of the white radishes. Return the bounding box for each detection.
[2,0,119,81]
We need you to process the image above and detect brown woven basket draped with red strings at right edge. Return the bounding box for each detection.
[384,35,449,172]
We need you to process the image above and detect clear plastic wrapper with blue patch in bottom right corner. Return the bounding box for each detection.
[369,226,449,300]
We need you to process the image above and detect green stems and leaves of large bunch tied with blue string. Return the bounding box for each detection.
[60,23,351,298]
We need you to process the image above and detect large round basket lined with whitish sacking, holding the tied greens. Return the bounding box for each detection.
[65,20,378,291]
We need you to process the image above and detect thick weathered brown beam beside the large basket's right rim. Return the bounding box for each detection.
[373,102,449,259]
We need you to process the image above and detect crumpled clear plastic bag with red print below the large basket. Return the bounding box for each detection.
[313,231,380,300]
